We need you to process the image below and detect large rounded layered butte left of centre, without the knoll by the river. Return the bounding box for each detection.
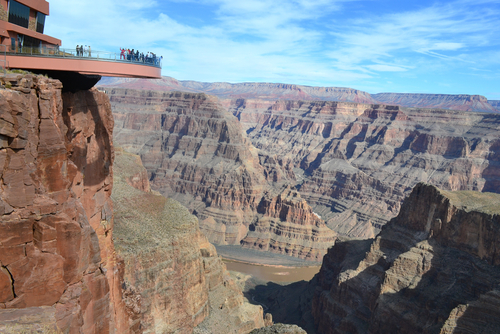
[108,90,265,244]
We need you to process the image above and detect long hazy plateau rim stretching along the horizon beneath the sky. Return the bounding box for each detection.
[99,77,500,112]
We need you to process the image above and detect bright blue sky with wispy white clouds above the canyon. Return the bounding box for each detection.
[45,0,500,100]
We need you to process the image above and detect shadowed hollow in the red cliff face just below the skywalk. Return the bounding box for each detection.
[62,91,113,186]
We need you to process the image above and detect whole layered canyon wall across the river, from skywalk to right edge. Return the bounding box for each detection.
[107,85,500,245]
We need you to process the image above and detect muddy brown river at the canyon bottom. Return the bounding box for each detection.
[224,259,321,283]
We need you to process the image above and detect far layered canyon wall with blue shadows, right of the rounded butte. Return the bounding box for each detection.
[232,101,500,238]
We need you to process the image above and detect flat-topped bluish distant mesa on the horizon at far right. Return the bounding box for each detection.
[372,93,498,113]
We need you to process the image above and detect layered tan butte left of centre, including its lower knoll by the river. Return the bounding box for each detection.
[107,89,336,261]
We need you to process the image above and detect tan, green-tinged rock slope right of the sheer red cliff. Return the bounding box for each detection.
[112,150,264,333]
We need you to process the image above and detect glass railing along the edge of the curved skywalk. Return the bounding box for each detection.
[0,45,163,68]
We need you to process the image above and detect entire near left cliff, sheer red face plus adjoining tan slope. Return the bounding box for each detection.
[0,74,272,334]
